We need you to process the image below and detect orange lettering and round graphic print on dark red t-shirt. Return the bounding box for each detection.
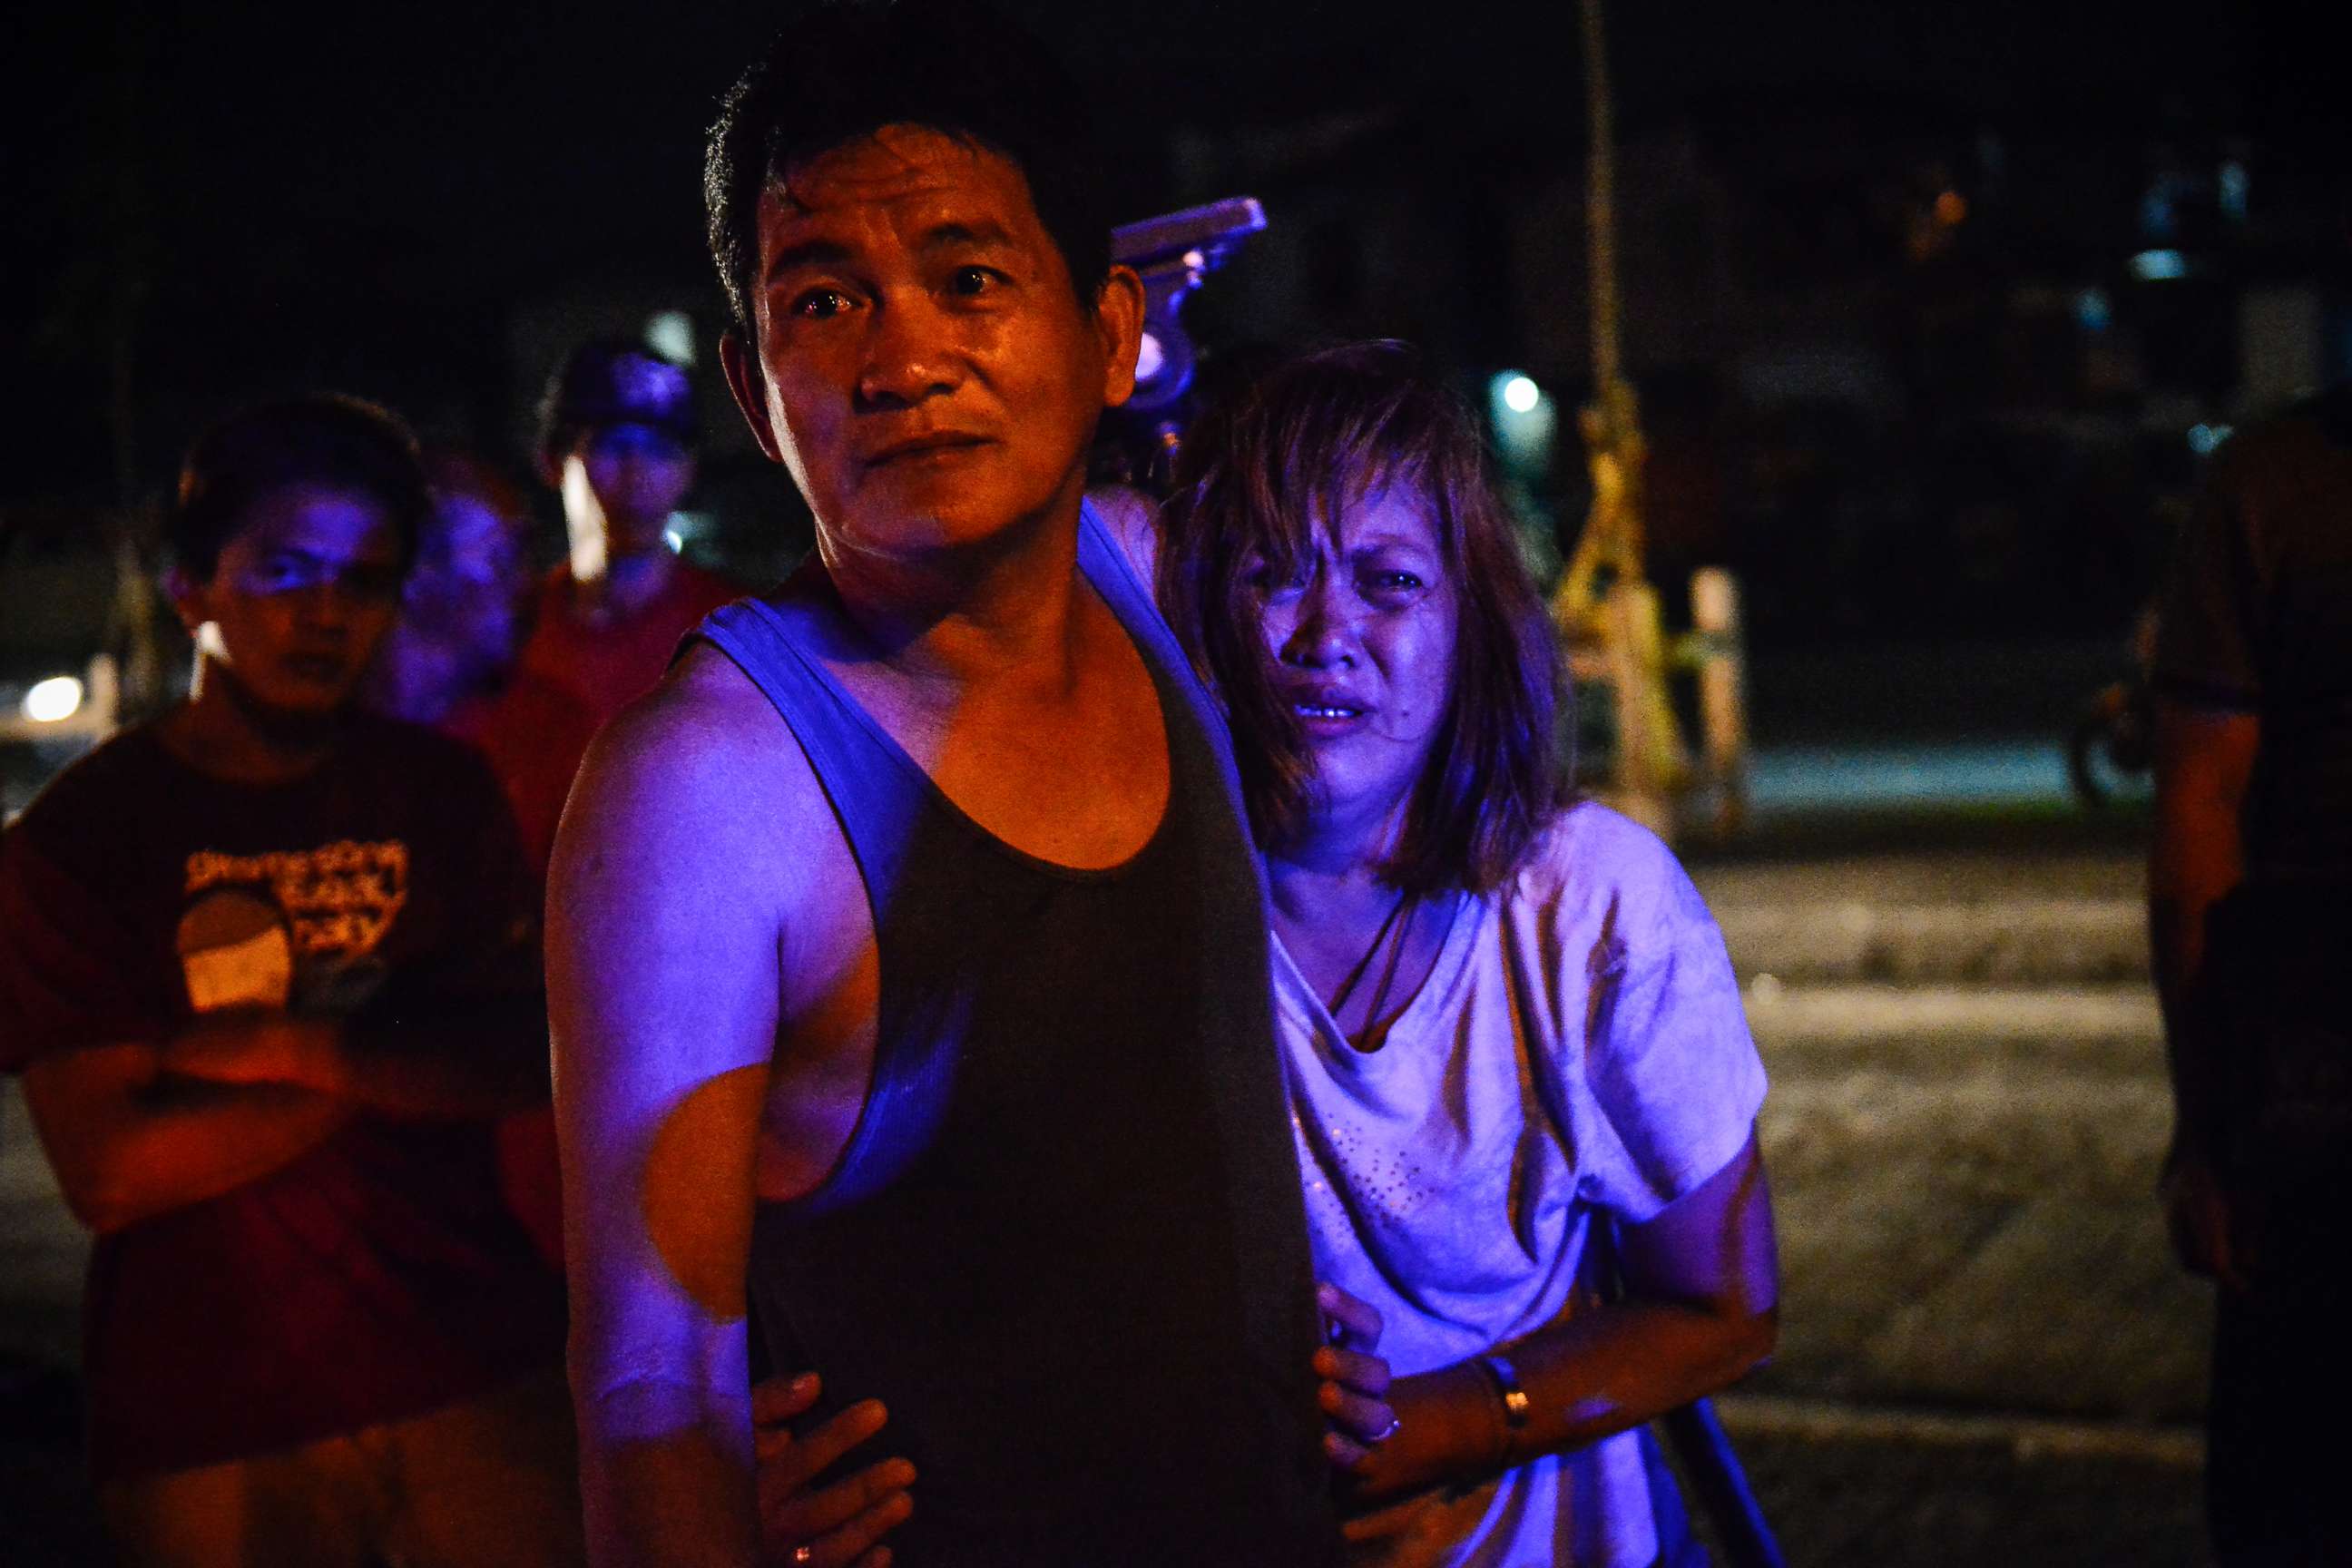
[179,839,409,1014]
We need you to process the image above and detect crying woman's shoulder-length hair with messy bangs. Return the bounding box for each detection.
[1160,341,1569,893]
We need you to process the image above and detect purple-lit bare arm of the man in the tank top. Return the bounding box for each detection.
[548,656,790,1568]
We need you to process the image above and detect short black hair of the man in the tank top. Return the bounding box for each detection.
[703,0,1110,331]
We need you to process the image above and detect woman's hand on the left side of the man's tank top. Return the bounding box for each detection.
[750,1373,915,1568]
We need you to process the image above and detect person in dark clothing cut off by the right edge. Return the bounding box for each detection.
[2150,387,2352,1563]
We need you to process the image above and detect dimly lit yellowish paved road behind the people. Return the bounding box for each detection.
[0,847,2209,1568]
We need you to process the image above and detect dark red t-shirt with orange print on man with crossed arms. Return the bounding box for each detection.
[0,720,564,1479]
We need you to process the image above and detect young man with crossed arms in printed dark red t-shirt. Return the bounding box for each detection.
[0,397,579,1568]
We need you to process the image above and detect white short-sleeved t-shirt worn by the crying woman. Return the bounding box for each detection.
[1275,804,1764,1568]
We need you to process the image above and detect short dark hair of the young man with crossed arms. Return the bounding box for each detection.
[164,393,433,581]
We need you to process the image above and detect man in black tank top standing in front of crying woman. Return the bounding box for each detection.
[548,0,1386,1568]
